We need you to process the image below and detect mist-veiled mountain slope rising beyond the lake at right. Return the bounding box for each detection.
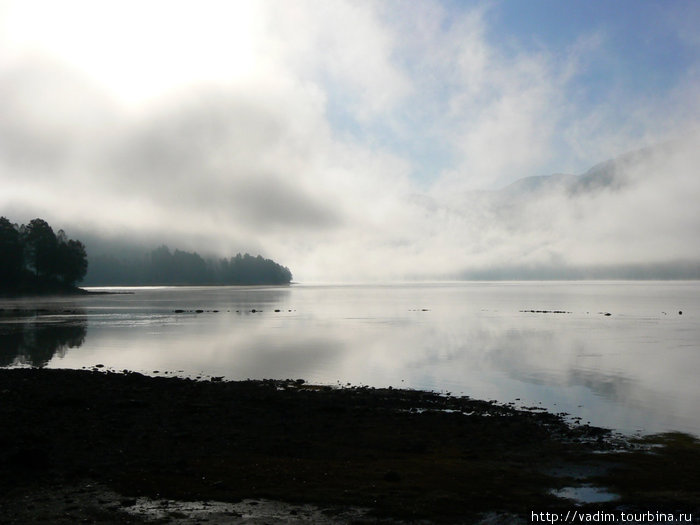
[454,133,700,280]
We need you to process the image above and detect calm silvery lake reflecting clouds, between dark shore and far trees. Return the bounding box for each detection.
[0,281,700,435]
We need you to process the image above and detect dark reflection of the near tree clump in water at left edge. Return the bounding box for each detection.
[0,308,87,367]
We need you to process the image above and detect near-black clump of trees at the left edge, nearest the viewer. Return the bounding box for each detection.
[0,217,88,293]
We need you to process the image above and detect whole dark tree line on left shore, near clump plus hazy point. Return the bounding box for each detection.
[0,217,292,288]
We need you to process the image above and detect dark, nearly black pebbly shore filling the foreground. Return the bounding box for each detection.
[0,369,700,523]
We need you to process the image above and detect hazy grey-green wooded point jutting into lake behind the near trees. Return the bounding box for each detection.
[86,245,292,286]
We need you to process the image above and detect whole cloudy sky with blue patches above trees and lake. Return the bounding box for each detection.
[0,0,700,281]
